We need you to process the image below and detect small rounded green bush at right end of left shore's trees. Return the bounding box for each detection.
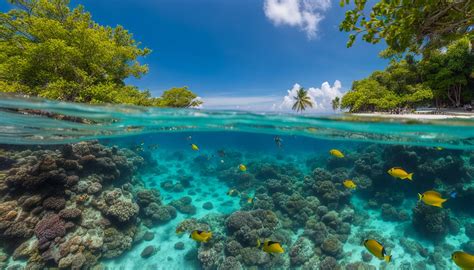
[159,86,202,108]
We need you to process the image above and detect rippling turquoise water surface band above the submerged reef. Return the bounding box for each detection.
[0,96,474,149]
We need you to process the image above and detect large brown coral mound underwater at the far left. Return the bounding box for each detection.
[0,142,180,269]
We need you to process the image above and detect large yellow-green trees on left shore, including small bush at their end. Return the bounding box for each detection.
[0,0,200,107]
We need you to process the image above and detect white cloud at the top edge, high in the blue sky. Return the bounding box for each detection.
[263,0,331,39]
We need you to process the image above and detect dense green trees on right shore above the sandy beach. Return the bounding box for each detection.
[341,38,474,112]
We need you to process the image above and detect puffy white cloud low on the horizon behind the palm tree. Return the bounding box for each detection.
[278,80,343,112]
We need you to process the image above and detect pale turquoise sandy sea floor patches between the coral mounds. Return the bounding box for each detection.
[103,149,470,270]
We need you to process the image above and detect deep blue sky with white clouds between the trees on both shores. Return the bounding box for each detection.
[0,0,386,111]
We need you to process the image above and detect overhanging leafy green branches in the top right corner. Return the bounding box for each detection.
[339,0,474,57]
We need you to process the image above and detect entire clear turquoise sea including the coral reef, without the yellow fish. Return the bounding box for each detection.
[0,96,474,269]
